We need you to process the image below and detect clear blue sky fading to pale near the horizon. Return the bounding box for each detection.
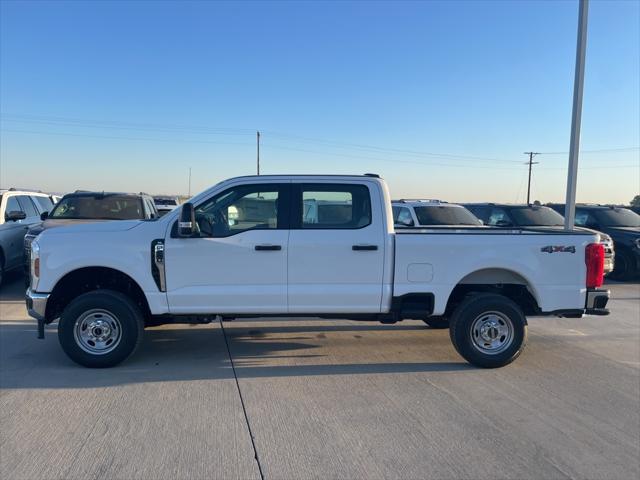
[0,0,640,202]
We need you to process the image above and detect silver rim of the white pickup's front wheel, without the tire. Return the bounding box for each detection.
[73,309,122,355]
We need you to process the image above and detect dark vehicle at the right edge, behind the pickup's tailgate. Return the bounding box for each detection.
[549,203,640,280]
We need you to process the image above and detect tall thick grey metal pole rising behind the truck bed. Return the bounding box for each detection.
[564,0,589,230]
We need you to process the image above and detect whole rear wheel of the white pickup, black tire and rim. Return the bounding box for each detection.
[449,293,527,368]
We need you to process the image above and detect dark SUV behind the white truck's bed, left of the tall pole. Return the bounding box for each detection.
[464,203,616,274]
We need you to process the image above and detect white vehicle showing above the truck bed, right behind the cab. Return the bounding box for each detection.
[391,199,482,227]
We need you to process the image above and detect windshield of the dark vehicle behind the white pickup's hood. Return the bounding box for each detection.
[49,194,144,220]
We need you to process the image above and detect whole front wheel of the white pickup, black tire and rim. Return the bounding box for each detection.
[58,290,144,368]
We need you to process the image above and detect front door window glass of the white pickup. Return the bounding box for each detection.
[195,185,279,237]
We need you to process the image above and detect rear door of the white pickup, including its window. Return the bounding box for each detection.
[288,181,385,313]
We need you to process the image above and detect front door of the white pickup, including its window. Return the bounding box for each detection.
[165,183,289,314]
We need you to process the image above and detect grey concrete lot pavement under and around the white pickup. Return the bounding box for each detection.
[0,277,640,479]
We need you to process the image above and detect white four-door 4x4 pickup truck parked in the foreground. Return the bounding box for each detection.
[26,175,609,367]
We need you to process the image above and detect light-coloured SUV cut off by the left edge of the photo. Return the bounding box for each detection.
[0,189,53,284]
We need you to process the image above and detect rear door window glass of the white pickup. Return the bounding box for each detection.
[302,184,371,229]
